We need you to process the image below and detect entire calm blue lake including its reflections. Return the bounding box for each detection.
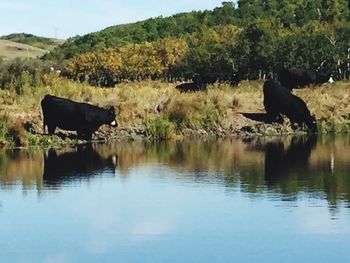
[0,136,350,263]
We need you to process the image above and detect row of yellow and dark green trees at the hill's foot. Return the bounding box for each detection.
[65,19,350,86]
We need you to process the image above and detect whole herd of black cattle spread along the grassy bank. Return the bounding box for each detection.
[41,69,333,140]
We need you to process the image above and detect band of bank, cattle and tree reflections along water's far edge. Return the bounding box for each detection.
[0,136,350,206]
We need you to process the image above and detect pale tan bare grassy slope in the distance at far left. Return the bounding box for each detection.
[0,40,48,62]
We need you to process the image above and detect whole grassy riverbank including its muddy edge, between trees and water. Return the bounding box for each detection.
[0,74,350,146]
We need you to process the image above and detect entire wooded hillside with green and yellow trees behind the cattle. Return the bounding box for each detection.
[2,0,350,86]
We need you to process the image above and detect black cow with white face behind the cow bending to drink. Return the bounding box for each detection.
[279,69,334,90]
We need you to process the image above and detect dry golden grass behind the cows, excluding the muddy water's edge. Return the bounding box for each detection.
[0,74,350,146]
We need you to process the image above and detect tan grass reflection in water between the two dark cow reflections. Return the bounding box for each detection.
[104,140,262,175]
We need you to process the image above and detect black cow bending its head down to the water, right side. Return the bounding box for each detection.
[263,80,317,132]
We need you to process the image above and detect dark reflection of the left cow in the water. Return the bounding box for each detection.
[43,145,118,185]
